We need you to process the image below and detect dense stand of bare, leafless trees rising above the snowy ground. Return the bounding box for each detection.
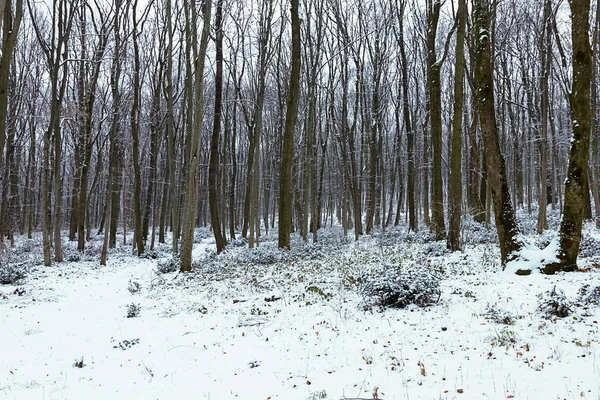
[0,0,600,273]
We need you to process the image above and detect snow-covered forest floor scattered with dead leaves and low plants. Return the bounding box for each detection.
[0,211,600,400]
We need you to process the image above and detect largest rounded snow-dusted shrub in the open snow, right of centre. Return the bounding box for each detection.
[359,262,442,308]
